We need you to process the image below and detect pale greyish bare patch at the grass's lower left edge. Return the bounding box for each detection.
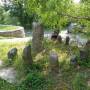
[0,60,17,83]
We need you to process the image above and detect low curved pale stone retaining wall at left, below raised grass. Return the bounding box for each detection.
[0,28,25,38]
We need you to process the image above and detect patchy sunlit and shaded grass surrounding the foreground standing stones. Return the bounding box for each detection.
[0,40,90,90]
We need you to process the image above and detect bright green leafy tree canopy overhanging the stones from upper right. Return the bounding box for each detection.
[25,0,90,28]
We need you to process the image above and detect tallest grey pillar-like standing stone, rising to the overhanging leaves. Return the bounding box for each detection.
[32,22,44,54]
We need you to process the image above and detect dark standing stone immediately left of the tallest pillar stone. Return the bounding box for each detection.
[22,45,33,65]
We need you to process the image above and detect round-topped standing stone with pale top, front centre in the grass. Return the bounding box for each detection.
[49,52,59,74]
